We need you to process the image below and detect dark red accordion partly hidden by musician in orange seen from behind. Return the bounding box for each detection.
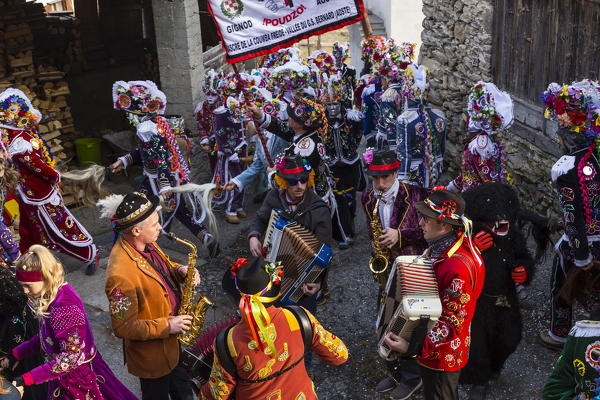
[181,315,240,386]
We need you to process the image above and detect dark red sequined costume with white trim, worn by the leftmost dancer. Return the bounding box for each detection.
[5,129,98,264]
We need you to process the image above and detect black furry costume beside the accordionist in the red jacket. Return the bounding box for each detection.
[460,182,534,385]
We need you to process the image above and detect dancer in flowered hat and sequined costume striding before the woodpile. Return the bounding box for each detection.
[113,81,212,246]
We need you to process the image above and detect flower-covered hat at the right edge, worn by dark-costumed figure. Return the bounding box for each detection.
[542,79,600,137]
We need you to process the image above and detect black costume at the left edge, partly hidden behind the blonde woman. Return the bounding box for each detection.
[0,268,48,400]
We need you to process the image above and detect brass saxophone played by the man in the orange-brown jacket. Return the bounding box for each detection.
[165,232,213,347]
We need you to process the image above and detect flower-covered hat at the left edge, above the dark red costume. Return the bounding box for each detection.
[0,88,42,131]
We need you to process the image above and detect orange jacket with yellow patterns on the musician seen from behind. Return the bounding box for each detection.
[200,306,348,400]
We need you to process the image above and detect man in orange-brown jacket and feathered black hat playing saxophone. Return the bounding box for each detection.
[99,192,200,400]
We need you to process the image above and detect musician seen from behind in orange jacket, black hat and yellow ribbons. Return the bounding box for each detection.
[200,257,348,400]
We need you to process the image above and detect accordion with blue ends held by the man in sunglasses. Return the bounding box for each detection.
[263,209,332,304]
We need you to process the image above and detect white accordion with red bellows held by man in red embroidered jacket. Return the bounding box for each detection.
[377,256,442,360]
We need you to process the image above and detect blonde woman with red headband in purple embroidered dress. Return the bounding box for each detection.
[1,245,136,400]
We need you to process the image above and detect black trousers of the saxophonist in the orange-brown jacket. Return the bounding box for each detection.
[140,364,196,400]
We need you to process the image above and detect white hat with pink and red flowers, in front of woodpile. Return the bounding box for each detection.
[112,81,167,115]
